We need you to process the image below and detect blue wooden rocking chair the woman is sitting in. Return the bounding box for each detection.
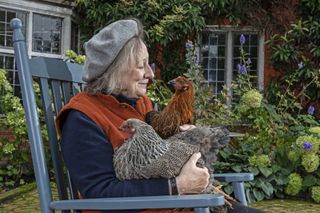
[10,18,253,213]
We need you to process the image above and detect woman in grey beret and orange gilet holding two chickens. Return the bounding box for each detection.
[57,20,264,212]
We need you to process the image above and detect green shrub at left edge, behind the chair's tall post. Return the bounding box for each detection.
[0,70,33,189]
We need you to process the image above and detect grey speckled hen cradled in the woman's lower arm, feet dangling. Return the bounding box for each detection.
[113,119,236,212]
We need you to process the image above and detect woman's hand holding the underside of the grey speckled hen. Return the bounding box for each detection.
[176,152,210,194]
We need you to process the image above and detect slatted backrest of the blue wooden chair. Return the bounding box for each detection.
[12,17,84,211]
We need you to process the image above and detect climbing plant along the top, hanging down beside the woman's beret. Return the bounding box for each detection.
[70,0,295,81]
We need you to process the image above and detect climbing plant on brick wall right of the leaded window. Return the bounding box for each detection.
[268,0,320,119]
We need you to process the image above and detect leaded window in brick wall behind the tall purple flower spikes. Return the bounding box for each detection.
[200,28,264,95]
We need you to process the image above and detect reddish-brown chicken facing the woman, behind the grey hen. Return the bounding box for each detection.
[146,76,194,139]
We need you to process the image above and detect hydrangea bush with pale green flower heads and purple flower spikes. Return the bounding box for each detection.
[185,35,320,202]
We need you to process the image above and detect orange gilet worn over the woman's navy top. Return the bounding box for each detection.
[56,92,193,213]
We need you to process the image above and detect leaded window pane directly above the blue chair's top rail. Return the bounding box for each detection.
[32,14,62,54]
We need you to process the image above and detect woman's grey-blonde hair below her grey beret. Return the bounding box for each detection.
[84,20,143,95]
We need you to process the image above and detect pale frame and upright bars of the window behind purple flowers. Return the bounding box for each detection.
[197,25,265,95]
